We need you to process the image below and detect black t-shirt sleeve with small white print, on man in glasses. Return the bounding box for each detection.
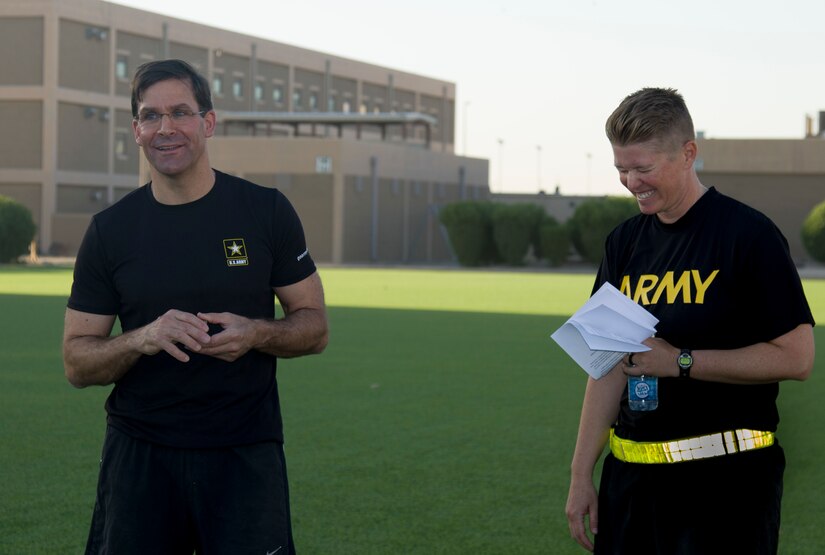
[270,192,315,287]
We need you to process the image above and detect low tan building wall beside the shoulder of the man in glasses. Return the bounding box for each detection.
[208,137,489,263]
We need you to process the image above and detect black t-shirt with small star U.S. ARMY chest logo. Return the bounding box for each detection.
[68,172,315,448]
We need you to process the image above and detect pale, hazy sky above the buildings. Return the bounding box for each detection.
[111,0,825,194]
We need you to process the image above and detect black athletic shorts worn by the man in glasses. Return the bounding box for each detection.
[86,426,295,555]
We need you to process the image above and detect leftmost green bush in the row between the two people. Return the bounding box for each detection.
[438,201,496,266]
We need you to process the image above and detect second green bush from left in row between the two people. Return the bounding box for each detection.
[493,203,544,266]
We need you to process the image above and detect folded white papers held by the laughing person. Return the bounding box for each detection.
[551,283,659,380]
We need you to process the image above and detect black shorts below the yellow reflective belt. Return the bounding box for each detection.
[595,444,785,555]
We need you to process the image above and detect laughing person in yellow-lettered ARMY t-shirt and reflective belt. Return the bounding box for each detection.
[566,89,814,555]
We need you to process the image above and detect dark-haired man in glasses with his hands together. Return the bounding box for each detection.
[63,60,328,554]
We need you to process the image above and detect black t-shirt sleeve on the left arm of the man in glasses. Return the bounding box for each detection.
[68,218,120,315]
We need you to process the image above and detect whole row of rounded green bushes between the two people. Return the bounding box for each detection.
[439,197,639,266]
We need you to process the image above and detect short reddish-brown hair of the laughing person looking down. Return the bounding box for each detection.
[605,88,696,150]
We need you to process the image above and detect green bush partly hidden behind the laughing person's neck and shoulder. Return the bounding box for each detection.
[567,197,639,264]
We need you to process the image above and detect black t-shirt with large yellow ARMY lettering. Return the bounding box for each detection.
[594,188,814,441]
